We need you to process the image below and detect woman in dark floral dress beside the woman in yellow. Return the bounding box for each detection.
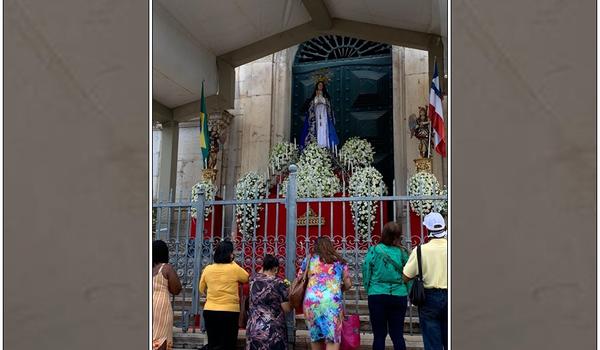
[246,254,292,350]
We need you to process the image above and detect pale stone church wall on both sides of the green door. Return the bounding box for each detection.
[157,47,447,204]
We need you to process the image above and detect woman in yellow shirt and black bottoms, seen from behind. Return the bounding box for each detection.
[200,241,248,350]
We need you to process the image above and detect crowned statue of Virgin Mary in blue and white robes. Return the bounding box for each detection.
[300,78,339,150]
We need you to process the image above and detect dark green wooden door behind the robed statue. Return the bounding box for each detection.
[291,55,394,190]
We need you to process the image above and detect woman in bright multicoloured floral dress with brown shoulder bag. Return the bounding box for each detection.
[298,237,352,350]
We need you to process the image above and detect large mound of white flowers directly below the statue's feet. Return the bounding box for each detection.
[280,143,341,198]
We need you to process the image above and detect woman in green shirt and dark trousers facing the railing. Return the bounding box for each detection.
[362,222,409,350]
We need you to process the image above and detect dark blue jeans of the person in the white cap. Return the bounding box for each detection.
[419,289,448,350]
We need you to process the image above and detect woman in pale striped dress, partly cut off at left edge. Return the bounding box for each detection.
[152,240,181,350]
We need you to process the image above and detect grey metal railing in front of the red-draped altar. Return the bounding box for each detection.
[152,166,447,339]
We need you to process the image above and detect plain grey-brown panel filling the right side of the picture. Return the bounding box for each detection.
[450,0,596,350]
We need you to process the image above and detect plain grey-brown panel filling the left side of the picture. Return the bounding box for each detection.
[4,0,149,350]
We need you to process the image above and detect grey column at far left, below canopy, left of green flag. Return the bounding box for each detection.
[158,121,179,201]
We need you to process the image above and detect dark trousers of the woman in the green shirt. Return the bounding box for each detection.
[369,294,408,350]
